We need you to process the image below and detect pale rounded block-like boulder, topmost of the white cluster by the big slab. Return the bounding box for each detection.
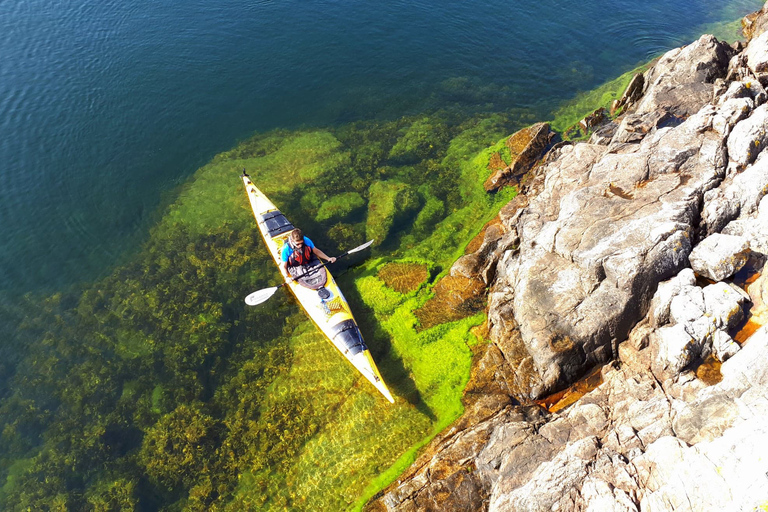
[688,233,749,281]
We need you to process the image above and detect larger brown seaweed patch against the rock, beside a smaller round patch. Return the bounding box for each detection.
[414,276,485,330]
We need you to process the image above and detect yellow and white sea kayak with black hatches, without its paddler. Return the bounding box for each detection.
[242,172,394,403]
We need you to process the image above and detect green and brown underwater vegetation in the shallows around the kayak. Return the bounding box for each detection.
[0,66,636,511]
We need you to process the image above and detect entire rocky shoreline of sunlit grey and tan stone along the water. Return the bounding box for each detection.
[366,4,768,511]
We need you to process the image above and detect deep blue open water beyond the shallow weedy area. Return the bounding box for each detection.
[0,0,761,292]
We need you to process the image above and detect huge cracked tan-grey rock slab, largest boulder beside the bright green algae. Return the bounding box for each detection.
[489,105,726,397]
